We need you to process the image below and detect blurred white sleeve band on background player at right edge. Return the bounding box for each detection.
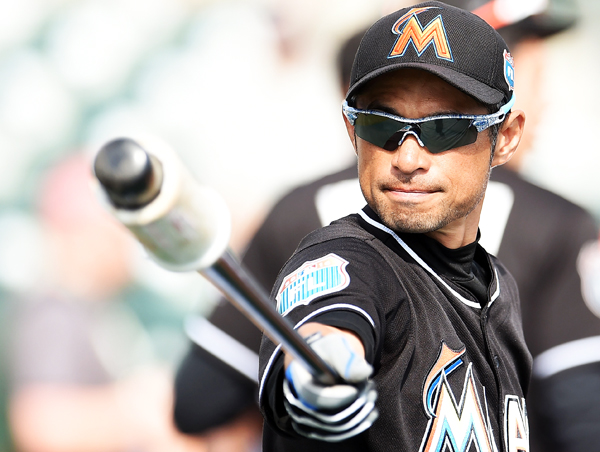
[533,336,600,378]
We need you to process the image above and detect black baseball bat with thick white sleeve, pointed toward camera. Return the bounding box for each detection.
[93,138,339,384]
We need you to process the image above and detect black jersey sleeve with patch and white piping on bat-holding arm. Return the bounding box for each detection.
[259,238,404,434]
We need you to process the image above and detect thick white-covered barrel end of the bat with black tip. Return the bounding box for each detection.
[94,137,231,272]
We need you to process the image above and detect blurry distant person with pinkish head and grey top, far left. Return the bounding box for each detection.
[9,155,206,452]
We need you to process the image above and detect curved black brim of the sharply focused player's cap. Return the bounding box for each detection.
[346,62,504,105]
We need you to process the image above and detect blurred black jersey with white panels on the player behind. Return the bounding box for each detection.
[177,165,600,452]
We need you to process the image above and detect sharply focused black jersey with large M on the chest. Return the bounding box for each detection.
[259,207,531,452]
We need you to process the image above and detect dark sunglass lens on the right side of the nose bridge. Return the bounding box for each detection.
[419,118,477,152]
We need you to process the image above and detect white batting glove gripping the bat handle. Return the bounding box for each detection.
[283,334,378,442]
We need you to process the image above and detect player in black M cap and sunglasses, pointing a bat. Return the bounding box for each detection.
[259,2,531,451]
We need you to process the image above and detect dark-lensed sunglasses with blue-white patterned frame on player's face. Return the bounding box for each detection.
[342,94,515,154]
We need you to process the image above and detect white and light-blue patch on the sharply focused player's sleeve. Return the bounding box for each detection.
[275,253,350,315]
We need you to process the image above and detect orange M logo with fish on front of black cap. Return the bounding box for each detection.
[388,6,453,61]
